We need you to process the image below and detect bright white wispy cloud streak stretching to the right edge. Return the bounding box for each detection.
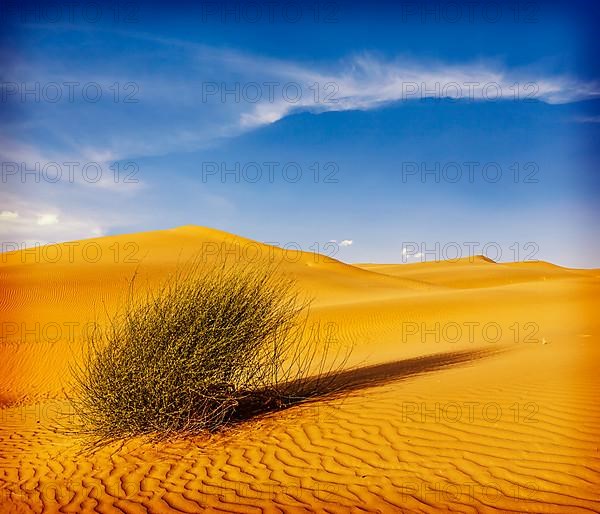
[231,54,600,129]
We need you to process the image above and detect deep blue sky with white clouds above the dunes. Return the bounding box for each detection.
[0,1,600,267]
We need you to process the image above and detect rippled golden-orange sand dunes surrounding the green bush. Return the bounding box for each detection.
[0,226,600,513]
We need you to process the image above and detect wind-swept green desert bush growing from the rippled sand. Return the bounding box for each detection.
[73,265,344,441]
